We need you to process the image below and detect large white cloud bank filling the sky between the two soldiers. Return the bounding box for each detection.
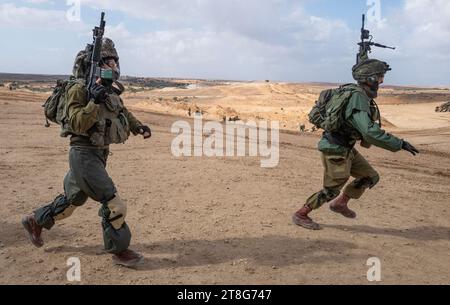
[83,0,353,81]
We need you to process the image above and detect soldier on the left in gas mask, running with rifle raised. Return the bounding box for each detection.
[22,38,151,267]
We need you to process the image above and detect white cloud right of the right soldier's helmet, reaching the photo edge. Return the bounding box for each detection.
[373,0,450,85]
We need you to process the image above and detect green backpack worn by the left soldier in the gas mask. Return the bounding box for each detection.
[42,77,84,137]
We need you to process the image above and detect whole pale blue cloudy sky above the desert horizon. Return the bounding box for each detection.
[0,0,450,86]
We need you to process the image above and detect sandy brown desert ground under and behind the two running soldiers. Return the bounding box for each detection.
[0,83,450,284]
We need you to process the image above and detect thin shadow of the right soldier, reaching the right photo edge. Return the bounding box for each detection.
[323,225,450,241]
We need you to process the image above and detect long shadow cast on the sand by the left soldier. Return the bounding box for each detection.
[50,236,367,270]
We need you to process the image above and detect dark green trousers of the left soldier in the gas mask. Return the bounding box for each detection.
[35,146,131,253]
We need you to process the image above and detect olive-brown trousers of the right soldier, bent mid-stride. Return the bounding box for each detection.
[306,149,380,210]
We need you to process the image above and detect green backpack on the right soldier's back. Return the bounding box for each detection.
[308,84,363,132]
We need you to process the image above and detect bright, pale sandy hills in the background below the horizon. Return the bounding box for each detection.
[125,83,450,130]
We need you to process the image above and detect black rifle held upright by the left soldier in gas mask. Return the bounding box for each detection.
[86,12,106,101]
